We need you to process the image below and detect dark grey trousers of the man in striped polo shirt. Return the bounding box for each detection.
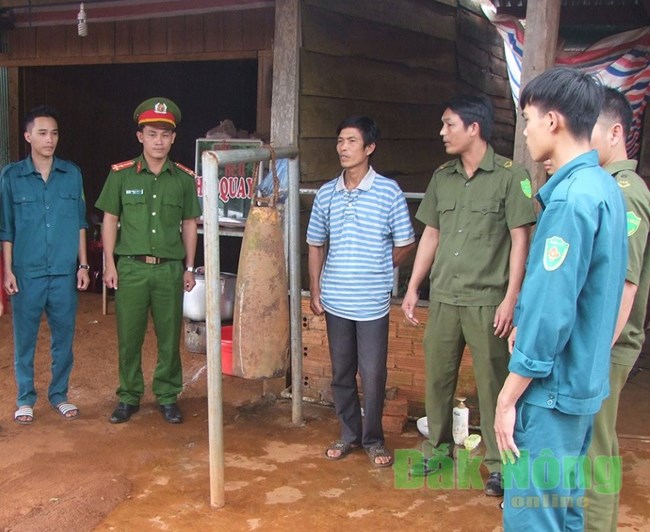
[325,313,388,448]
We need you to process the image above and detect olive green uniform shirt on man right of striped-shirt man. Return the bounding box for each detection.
[416,145,535,306]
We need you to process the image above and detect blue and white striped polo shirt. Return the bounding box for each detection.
[307,167,415,321]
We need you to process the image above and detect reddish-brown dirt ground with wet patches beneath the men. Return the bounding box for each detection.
[0,293,650,532]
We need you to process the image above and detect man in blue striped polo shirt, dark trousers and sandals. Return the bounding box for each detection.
[307,117,415,467]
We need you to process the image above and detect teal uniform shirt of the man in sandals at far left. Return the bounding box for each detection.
[0,156,88,278]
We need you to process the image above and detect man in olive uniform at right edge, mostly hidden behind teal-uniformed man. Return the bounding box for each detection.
[585,87,650,532]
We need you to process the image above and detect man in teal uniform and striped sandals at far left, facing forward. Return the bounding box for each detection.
[0,106,89,425]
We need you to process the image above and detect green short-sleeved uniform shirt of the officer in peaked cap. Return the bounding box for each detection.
[95,155,201,260]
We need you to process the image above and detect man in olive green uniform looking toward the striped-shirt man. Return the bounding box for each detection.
[402,95,535,496]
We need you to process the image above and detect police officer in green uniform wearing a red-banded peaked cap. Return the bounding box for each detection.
[95,98,201,423]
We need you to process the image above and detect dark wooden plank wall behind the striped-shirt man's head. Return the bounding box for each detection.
[299,0,456,191]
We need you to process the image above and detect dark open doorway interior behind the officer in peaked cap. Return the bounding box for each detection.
[20,60,257,223]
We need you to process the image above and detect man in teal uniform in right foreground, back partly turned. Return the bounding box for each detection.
[494,67,627,532]
